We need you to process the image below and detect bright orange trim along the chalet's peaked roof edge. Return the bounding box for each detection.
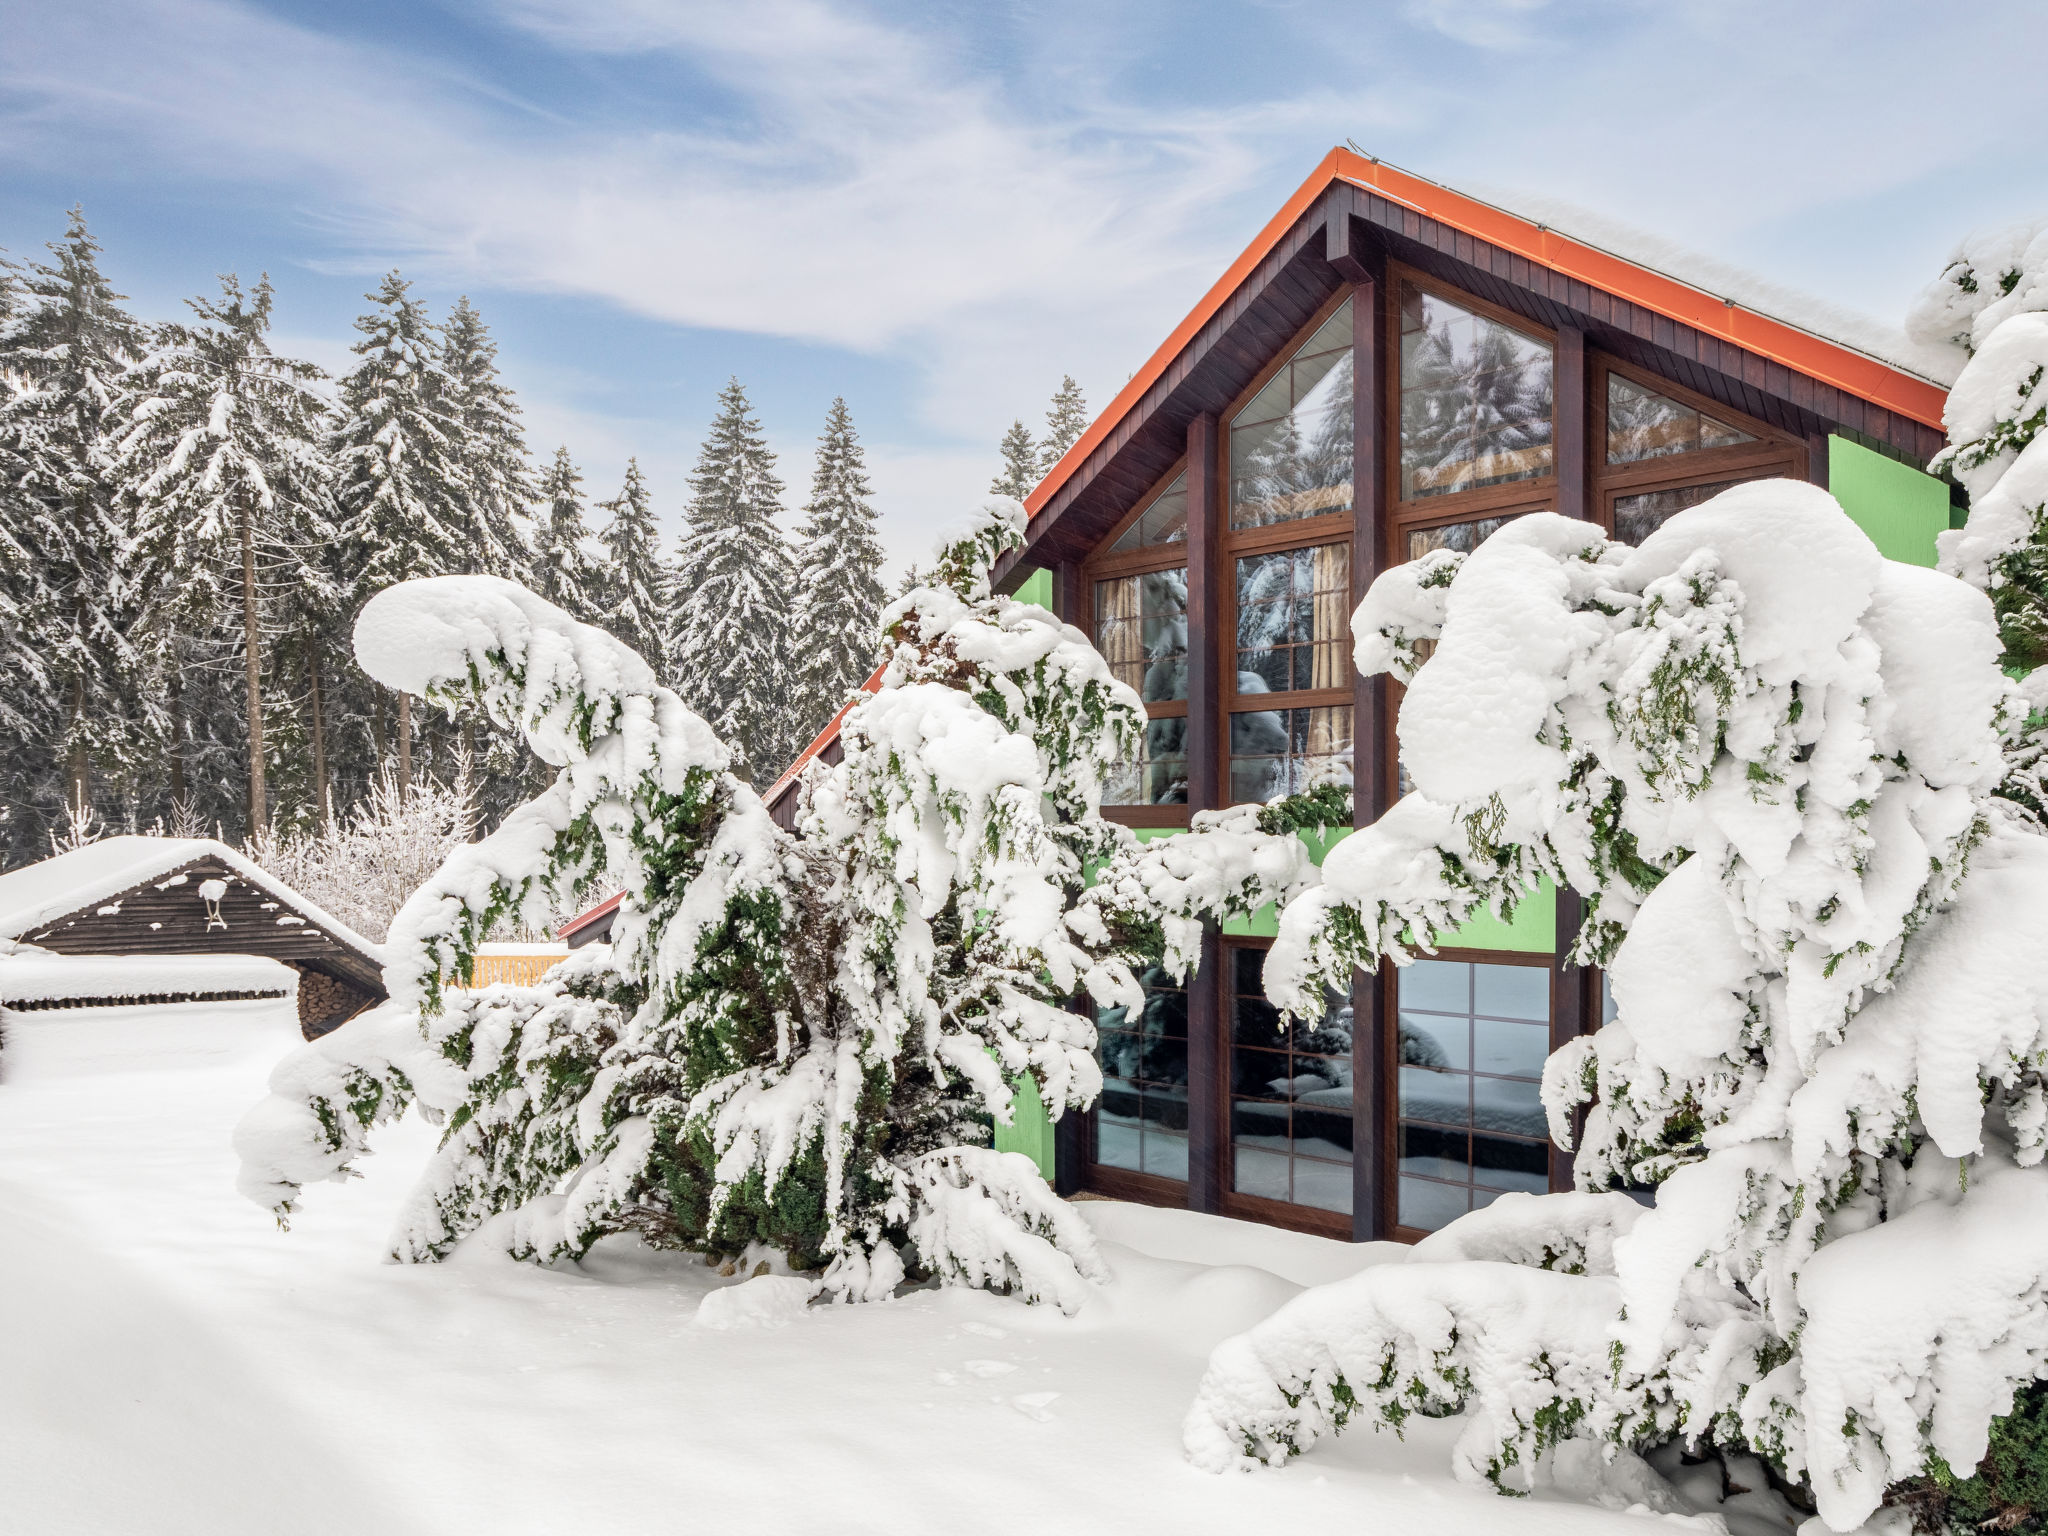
[1024,150,1948,516]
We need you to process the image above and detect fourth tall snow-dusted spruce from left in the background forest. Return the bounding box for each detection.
[440,297,535,582]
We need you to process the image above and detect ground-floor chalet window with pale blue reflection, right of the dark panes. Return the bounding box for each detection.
[1395,958,1550,1231]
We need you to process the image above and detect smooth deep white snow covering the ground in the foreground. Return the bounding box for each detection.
[0,1004,1761,1536]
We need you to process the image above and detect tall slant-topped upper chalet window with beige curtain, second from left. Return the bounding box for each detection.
[1223,299,1354,803]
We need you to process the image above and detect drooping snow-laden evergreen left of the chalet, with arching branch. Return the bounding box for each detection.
[238,500,1141,1309]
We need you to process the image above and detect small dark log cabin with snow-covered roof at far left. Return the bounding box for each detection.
[0,838,387,1040]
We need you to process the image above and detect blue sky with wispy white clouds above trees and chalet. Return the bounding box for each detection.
[0,0,2048,577]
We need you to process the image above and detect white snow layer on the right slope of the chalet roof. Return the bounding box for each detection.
[1454,182,1966,389]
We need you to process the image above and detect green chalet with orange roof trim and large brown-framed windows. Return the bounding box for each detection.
[768,150,1952,1239]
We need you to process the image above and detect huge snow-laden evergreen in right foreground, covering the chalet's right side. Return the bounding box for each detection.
[1188,481,2048,1530]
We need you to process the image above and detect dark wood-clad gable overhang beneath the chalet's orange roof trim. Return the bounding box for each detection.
[995,182,1946,590]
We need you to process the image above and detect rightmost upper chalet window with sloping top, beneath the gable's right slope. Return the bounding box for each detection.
[1593,360,1806,545]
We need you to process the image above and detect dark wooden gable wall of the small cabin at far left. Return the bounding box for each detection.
[20,856,387,1038]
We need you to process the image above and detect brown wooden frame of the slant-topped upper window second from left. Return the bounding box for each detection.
[1210,283,1358,819]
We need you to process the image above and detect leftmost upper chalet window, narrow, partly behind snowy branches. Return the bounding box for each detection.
[1090,471,1188,815]
